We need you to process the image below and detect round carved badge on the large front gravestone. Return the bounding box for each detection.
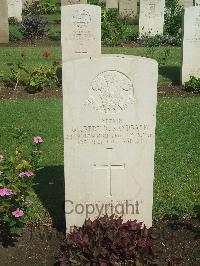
[87,70,134,114]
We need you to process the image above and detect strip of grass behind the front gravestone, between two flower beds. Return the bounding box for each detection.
[0,47,181,85]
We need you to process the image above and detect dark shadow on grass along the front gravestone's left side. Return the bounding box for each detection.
[34,165,65,230]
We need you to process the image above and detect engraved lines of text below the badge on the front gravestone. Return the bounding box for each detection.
[65,118,153,145]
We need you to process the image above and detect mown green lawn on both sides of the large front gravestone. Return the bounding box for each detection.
[0,97,200,222]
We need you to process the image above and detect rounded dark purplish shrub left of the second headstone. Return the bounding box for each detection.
[21,15,48,39]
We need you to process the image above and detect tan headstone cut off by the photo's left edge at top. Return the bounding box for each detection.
[0,0,9,43]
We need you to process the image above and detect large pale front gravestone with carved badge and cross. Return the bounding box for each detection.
[63,55,158,231]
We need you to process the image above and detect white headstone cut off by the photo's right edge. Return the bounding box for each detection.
[182,6,200,84]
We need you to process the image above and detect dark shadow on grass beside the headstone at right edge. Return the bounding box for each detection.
[159,66,181,86]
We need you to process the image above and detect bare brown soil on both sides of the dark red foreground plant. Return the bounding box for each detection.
[0,220,200,266]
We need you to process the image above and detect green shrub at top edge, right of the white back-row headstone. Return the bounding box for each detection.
[165,0,184,37]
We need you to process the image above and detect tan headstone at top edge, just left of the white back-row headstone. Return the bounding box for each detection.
[119,0,137,17]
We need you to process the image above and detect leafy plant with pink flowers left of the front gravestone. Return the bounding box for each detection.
[0,129,43,241]
